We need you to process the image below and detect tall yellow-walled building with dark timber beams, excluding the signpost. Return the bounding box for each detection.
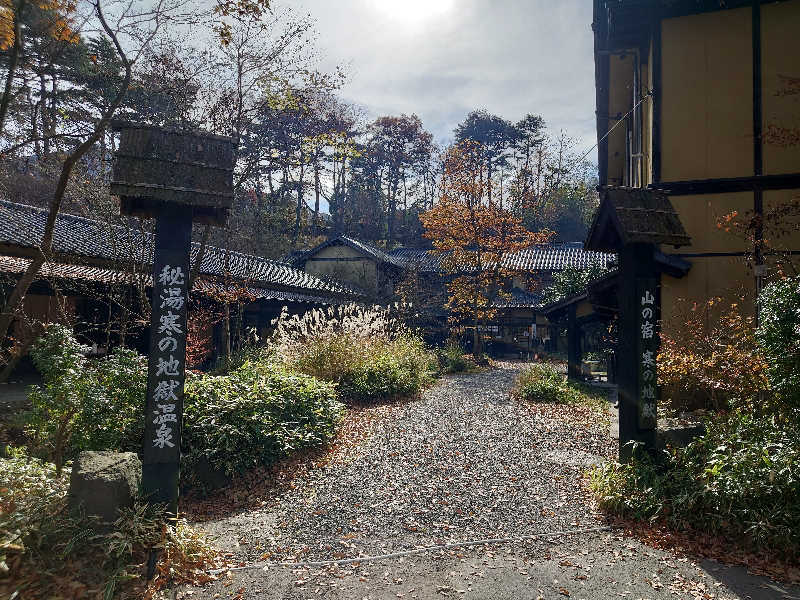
[593,0,800,328]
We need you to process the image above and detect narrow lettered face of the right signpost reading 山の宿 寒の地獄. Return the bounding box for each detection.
[636,277,658,430]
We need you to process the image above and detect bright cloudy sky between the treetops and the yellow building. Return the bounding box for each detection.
[291,0,596,157]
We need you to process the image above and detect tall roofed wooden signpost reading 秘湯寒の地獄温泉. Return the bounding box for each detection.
[111,123,235,514]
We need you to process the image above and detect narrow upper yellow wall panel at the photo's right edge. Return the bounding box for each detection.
[761,2,800,174]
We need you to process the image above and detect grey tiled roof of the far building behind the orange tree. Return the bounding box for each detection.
[390,244,616,271]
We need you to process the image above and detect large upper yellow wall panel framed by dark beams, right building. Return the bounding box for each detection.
[661,8,753,181]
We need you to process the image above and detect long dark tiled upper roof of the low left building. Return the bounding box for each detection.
[0,200,365,298]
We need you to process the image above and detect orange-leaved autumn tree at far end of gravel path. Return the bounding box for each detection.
[420,140,551,358]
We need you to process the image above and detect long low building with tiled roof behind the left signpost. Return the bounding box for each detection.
[0,201,370,368]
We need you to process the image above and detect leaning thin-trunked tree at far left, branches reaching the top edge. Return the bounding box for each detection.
[0,0,282,376]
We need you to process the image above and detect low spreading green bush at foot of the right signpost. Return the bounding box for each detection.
[590,411,800,556]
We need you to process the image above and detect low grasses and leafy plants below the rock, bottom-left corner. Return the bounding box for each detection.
[0,449,223,600]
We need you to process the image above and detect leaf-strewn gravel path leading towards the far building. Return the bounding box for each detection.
[200,363,610,561]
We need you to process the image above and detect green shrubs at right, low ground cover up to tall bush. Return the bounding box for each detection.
[590,277,800,562]
